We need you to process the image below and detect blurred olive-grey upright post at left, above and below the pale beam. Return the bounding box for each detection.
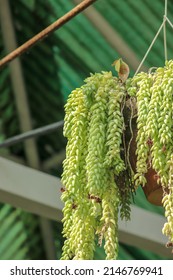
[0,0,56,259]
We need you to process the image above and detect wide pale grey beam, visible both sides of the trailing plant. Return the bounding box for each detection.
[0,155,173,258]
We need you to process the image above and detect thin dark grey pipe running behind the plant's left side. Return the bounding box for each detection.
[0,120,64,148]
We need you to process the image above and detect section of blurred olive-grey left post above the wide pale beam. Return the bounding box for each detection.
[0,0,39,168]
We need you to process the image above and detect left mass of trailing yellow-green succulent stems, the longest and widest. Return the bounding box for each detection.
[62,72,129,259]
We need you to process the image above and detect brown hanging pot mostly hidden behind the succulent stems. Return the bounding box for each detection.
[124,100,163,206]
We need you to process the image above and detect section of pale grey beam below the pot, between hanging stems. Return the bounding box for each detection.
[119,206,170,258]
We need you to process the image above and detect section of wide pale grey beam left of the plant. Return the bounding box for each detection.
[0,157,63,220]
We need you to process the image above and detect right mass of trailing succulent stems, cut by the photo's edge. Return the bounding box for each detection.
[128,60,173,245]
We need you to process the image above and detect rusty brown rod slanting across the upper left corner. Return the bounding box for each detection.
[0,0,97,68]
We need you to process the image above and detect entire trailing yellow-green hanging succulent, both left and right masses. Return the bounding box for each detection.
[62,60,173,260]
